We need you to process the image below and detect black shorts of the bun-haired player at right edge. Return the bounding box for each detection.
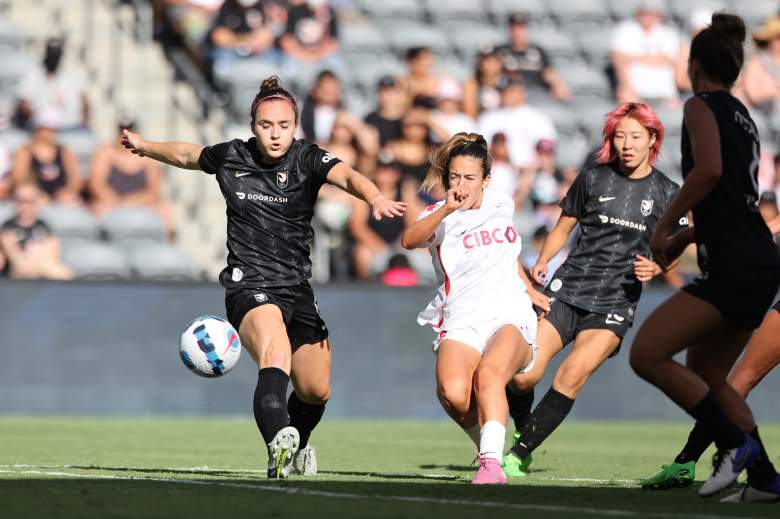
[683,269,780,330]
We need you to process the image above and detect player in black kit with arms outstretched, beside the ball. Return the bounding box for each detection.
[123,76,406,478]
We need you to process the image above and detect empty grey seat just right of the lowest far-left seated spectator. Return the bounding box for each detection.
[62,242,132,280]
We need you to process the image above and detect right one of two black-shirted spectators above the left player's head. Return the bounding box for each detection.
[279,0,343,74]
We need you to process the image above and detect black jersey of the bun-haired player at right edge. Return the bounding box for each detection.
[682,92,780,275]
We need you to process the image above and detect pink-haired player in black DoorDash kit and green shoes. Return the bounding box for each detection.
[503,103,678,477]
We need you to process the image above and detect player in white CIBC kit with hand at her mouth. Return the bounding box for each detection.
[401,133,549,484]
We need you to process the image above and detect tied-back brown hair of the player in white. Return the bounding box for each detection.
[420,132,493,193]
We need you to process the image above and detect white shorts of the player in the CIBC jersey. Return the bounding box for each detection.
[433,306,538,373]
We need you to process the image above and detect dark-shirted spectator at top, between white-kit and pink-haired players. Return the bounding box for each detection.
[496,12,571,101]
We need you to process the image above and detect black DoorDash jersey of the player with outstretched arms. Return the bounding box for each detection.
[199,137,341,288]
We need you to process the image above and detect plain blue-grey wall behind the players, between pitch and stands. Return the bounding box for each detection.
[0,281,780,421]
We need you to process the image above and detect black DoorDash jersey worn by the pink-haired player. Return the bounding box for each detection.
[547,164,687,319]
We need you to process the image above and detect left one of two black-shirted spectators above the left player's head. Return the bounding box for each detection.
[209,0,279,80]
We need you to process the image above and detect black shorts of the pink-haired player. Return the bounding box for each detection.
[544,299,632,357]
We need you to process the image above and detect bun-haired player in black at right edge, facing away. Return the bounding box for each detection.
[631,13,780,502]
